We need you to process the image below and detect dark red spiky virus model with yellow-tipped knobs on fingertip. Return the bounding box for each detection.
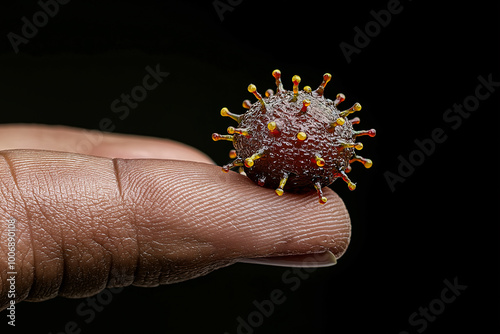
[212,70,375,204]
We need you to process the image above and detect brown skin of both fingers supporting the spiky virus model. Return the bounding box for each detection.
[0,125,350,310]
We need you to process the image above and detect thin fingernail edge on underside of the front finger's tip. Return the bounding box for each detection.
[238,251,337,268]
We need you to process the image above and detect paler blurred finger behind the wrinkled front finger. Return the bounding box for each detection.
[0,124,213,163]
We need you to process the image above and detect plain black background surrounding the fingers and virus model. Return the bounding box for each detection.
[0,0,500,334]
